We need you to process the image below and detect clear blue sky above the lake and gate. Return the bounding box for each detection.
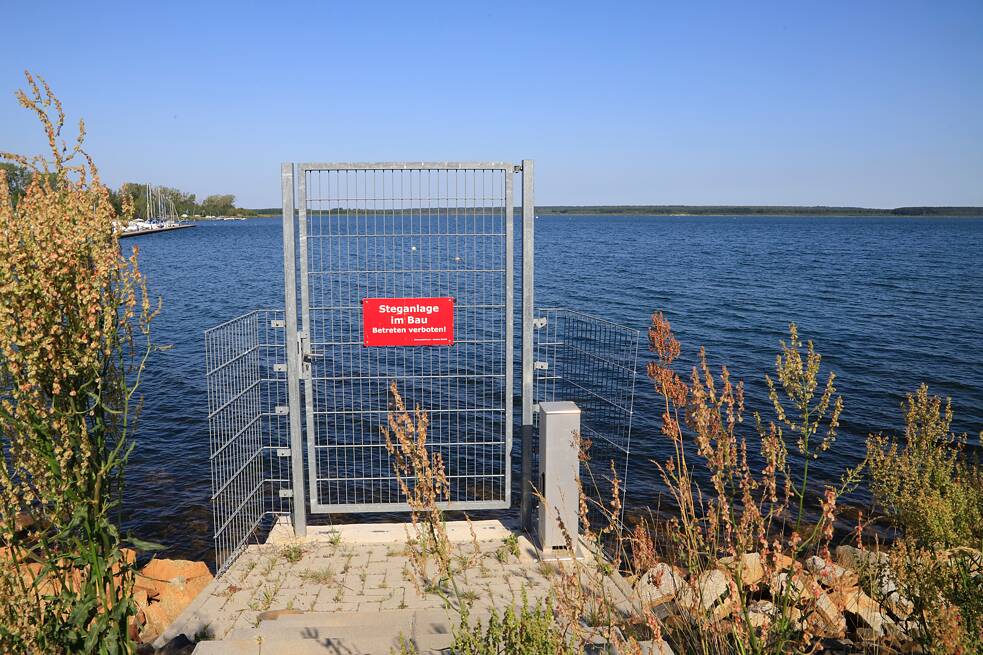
[0,0,983,207]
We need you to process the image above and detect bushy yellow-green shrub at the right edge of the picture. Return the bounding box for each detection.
[867,385,983,654]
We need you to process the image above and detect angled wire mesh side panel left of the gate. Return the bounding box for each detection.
[205,310,290,571]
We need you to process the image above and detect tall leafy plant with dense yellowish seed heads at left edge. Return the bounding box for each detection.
[0,74,156,654]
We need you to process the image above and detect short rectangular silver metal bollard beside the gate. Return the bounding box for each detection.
[538,401,580,555]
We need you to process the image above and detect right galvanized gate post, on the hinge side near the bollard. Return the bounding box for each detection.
[520,159,536,533]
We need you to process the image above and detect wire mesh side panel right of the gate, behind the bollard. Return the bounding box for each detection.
[534,309,641,524]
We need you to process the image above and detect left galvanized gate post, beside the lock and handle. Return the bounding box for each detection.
[280,164,307,537]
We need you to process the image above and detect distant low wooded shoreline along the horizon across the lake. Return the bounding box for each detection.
[238,205,983,218]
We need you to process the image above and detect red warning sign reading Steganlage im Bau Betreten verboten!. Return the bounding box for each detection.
[362,298,454,346]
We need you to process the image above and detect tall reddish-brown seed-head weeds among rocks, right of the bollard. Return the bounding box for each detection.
[644,313,860,653]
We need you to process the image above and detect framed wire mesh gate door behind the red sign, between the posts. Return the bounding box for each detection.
[298,164,513,513]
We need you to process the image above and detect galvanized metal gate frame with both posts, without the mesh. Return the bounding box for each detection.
[281,159,535,537]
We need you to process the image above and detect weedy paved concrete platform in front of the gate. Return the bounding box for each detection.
[156,521,556,655]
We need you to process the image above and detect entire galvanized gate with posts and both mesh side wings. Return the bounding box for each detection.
[205,160,640,572]
